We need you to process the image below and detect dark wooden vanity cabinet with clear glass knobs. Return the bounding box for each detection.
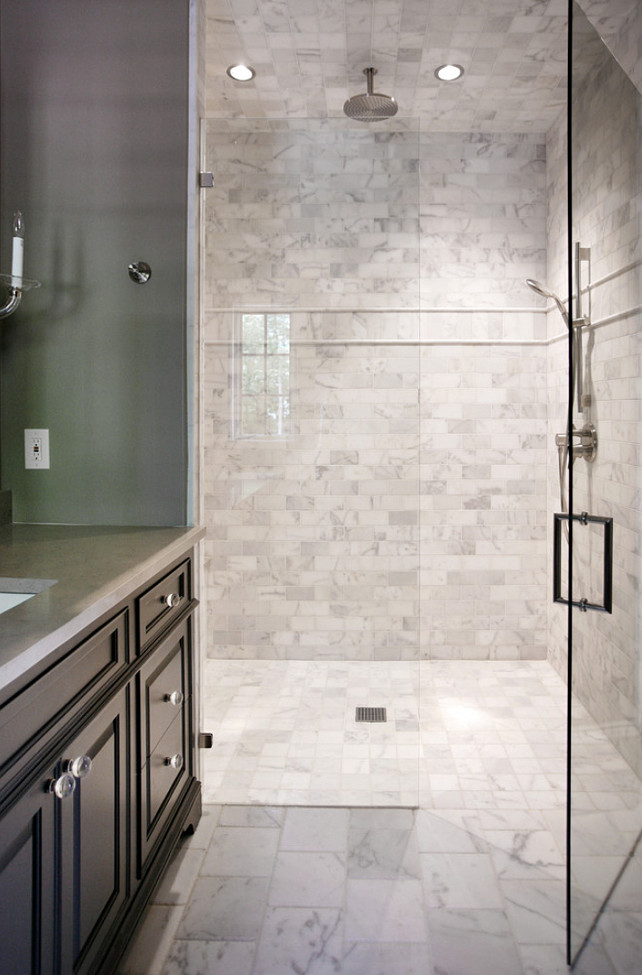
[0,559,200,975]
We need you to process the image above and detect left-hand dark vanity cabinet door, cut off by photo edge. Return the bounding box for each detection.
[0,780,55,975]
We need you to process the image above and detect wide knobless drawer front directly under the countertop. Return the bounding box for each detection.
[0,610,127,769]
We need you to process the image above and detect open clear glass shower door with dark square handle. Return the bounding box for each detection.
[568,4,642,970]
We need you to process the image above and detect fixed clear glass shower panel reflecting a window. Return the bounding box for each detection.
[202,117,420,806]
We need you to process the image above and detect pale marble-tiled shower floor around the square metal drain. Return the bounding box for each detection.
[203,660,566,809]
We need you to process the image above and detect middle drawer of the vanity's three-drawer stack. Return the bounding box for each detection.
[140,620,189,764]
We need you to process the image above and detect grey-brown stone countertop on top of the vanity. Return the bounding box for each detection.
[0,525,205,701]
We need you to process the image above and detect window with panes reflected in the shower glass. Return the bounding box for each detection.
[235,312,290,437]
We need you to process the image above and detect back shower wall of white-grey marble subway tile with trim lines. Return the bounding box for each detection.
[203,120,546,659]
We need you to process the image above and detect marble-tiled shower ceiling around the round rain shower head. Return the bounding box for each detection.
[206,0,629,132]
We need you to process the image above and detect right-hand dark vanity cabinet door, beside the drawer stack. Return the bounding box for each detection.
[62,688,130,972]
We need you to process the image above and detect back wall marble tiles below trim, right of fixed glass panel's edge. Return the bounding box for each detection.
[420,344,547,659]
